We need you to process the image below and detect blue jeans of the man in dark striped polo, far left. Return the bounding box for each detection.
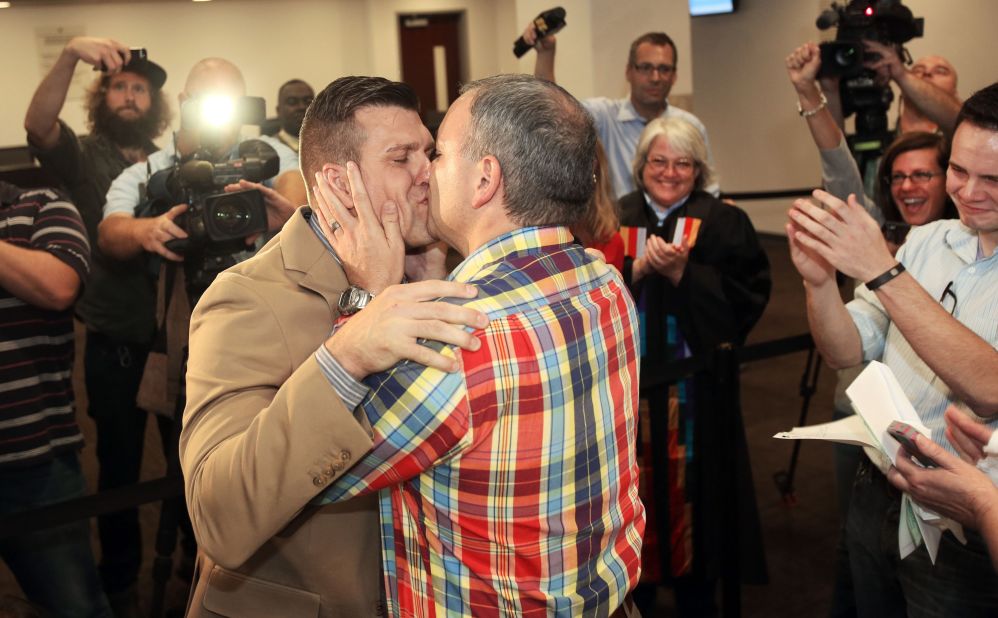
[0,452,112,618]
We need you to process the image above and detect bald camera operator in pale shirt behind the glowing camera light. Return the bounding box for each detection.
[98,58,300,262]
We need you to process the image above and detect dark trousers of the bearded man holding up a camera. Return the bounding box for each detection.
[83,331,150,594]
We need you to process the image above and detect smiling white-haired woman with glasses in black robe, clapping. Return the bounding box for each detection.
[620,118,771,616]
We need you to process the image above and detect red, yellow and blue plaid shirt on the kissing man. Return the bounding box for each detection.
[318,228,645,616]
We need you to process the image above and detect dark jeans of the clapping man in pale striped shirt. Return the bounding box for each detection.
[847,458,998,618]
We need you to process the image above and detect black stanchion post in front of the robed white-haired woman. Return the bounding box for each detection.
[714,343,742,618]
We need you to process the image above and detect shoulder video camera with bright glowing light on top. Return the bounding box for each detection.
[142,97,280,256]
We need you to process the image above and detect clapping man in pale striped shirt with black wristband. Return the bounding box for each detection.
[787,84,998,616]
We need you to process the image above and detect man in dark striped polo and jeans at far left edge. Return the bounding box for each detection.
[0,182,112,617]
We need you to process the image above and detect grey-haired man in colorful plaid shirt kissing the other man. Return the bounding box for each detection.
[317,76,644,616]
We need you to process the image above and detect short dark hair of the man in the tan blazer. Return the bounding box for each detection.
[299,76,419,186]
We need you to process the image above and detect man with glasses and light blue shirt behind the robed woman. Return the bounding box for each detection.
[523,22,720,199]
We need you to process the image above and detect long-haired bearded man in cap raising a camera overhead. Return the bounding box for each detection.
[24,37,170,616]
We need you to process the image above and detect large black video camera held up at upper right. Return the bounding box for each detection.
[816,0,925,156]
